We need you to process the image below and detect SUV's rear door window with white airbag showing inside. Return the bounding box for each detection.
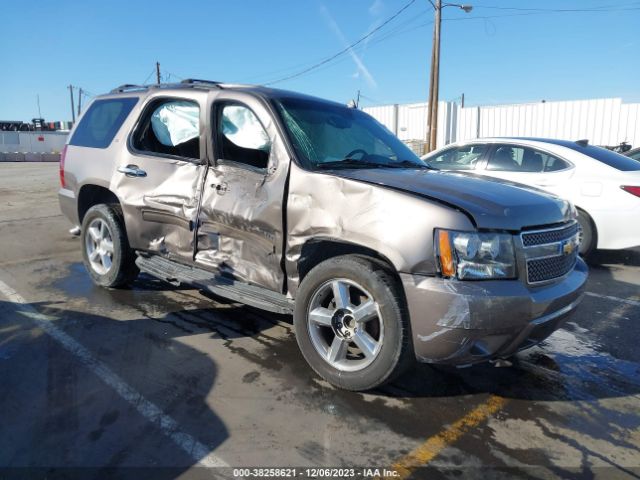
[133,100,200,159]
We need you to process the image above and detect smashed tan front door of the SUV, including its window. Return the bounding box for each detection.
[195,90,289,291]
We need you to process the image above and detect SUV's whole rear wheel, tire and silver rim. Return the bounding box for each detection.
[80,204,140,288]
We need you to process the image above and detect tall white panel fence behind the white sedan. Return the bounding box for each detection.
[363,98,640,151]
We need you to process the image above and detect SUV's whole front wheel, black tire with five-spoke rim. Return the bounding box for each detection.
[294,255,415,391]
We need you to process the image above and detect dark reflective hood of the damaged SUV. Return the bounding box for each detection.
[331,168,572,230]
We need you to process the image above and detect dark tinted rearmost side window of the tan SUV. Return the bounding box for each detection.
[69,97,138,148]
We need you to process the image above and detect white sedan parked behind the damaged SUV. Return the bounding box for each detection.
[422,138,640,255]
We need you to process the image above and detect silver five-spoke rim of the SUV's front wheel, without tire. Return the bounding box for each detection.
[307,278,384,372]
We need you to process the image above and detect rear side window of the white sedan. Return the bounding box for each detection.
[487,145,569,173]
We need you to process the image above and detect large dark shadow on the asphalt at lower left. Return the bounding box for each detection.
[0,301,229,480]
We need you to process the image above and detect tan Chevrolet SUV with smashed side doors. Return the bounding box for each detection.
[59,80,587,390]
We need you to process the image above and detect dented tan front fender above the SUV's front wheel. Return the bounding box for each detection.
[286,164,473,295]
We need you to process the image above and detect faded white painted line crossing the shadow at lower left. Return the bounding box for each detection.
[0,280,229,467]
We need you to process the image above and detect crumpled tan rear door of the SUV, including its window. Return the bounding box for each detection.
[112,91,207,262]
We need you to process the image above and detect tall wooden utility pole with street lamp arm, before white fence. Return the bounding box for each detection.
[425,0,473,153]
